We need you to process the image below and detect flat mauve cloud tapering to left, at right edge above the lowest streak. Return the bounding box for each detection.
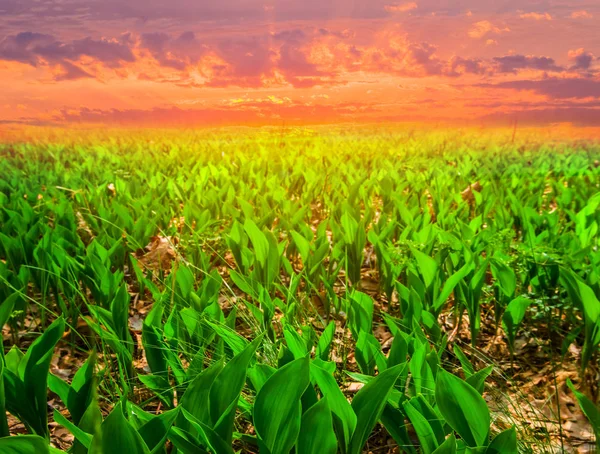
[479,78,600,99]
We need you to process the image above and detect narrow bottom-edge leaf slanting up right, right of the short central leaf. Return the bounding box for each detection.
[349,364,406,454]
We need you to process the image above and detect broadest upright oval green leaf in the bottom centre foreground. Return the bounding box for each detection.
[254,357,310,454]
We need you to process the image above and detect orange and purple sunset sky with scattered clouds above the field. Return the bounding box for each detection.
[0,0,600,127]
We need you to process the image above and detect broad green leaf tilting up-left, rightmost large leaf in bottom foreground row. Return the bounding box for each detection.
[435,369,490,448]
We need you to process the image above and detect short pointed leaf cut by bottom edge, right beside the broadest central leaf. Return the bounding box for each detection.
[296,397,338,454]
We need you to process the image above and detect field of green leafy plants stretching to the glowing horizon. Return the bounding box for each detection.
[0,127,600,454]
